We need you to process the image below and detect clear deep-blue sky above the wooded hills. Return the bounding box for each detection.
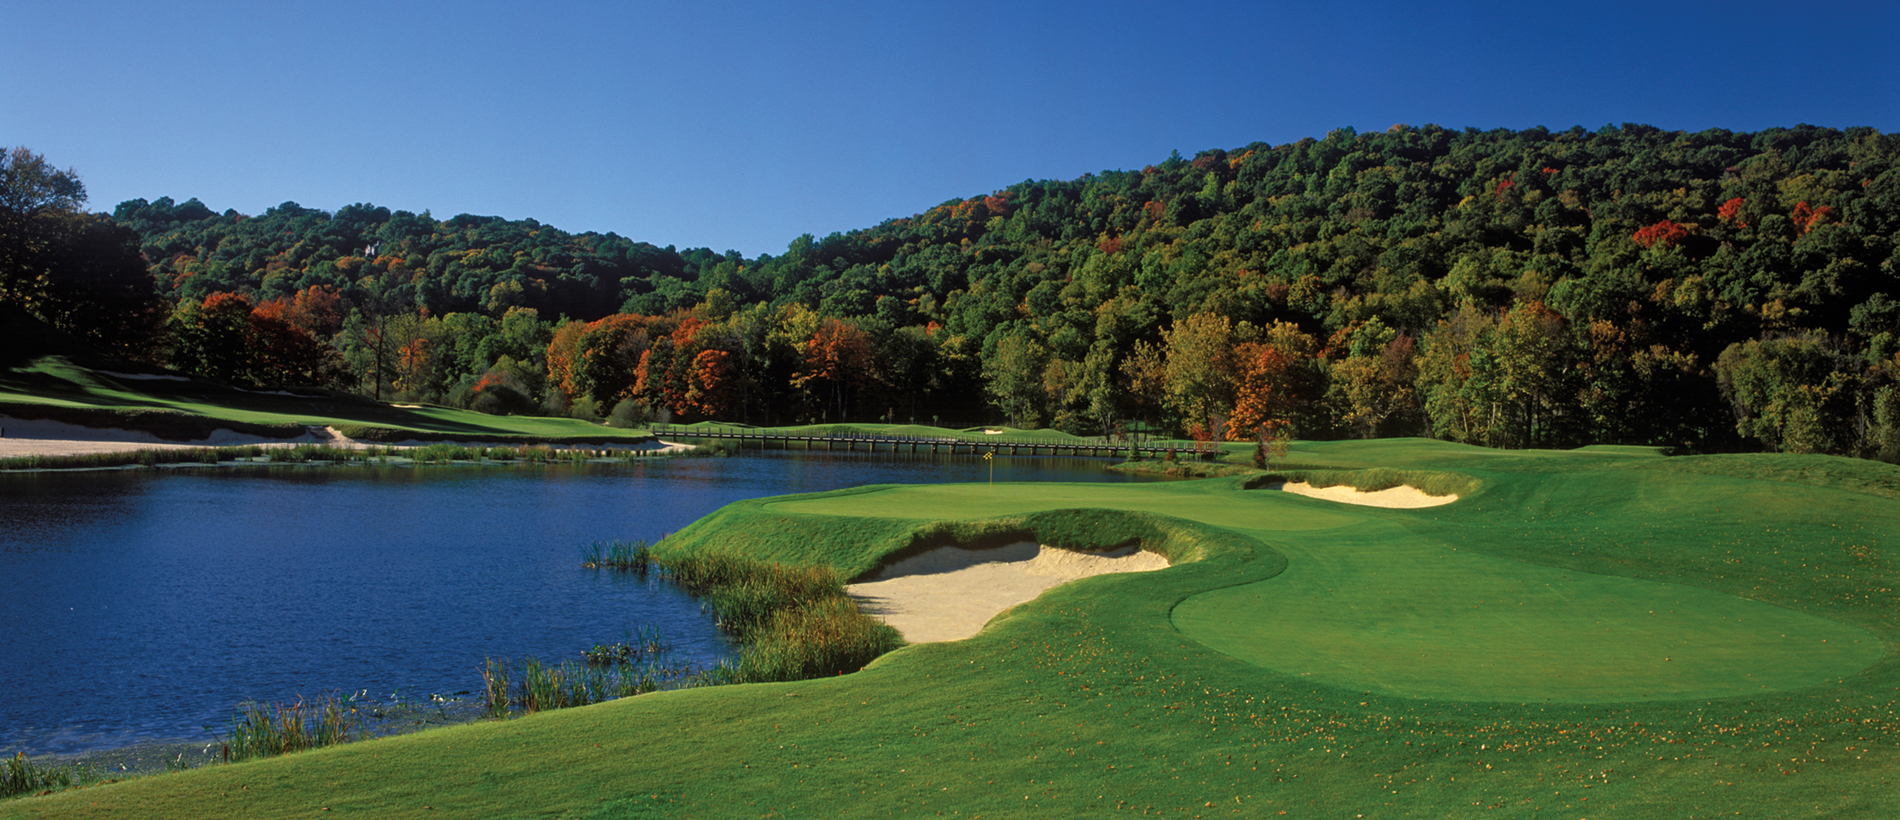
[0,0,1900,256]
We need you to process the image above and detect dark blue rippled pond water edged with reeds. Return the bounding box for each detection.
[0,454,1121,754]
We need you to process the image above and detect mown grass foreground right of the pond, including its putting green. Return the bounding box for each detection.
[0,440,1900,818]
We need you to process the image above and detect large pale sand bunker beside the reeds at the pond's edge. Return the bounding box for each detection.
[846,541,1169,643]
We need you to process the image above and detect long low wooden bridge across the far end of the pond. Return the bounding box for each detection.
[650,425,1191,457]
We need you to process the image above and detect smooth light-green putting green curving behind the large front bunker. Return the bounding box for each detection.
[786,480,1887,702]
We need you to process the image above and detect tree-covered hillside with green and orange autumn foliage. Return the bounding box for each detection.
[11,125,1900,459]
